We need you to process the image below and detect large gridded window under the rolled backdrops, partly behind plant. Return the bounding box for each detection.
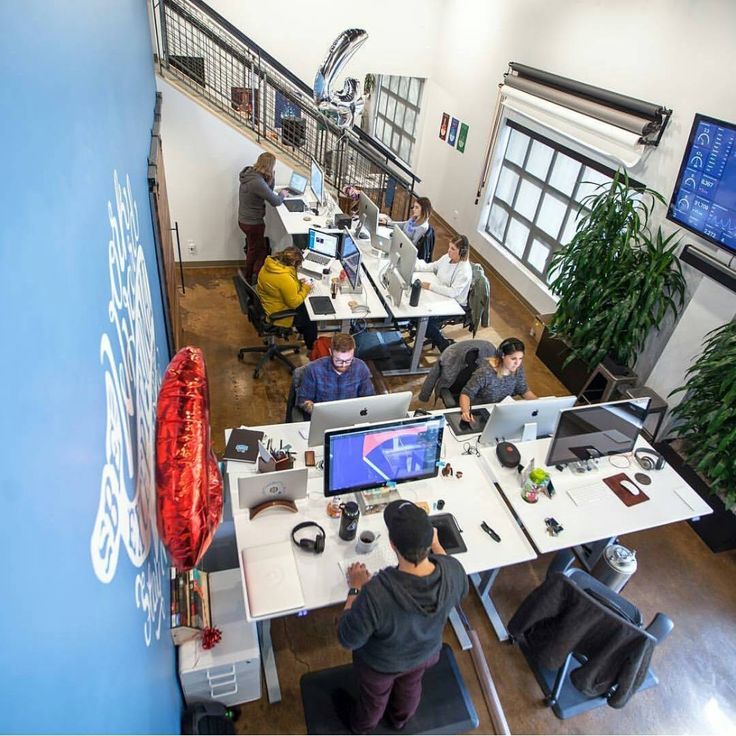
[485,120,614,282]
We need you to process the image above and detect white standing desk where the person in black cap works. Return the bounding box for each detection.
[226,422,536,702]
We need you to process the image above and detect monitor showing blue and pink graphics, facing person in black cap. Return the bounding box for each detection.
[324,414,445,496]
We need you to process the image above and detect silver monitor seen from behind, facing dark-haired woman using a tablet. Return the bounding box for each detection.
[478,396,577,445]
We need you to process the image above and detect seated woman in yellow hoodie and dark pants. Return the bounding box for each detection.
[256,247,317,350]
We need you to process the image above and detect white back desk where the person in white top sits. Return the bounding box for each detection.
[355,240,465,376]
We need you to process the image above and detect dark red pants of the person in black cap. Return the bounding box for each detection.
[350,652,440,733]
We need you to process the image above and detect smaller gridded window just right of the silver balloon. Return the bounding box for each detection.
[373,75,424,164]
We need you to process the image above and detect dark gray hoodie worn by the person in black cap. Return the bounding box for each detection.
[337,554,468,672]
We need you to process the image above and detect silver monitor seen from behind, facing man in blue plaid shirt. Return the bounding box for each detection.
[307,391,412,447]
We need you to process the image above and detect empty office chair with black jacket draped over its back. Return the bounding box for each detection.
[508,568,674,719]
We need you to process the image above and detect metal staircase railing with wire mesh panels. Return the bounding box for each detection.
[152,0,420,216]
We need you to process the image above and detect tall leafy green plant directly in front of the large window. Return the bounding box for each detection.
[549,172,685,369]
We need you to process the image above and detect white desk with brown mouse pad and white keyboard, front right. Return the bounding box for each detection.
[481,437,712,553]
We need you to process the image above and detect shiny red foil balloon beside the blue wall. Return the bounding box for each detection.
[156,347,222,571]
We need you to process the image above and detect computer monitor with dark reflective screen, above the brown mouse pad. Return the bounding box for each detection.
[546,398,649,466]
